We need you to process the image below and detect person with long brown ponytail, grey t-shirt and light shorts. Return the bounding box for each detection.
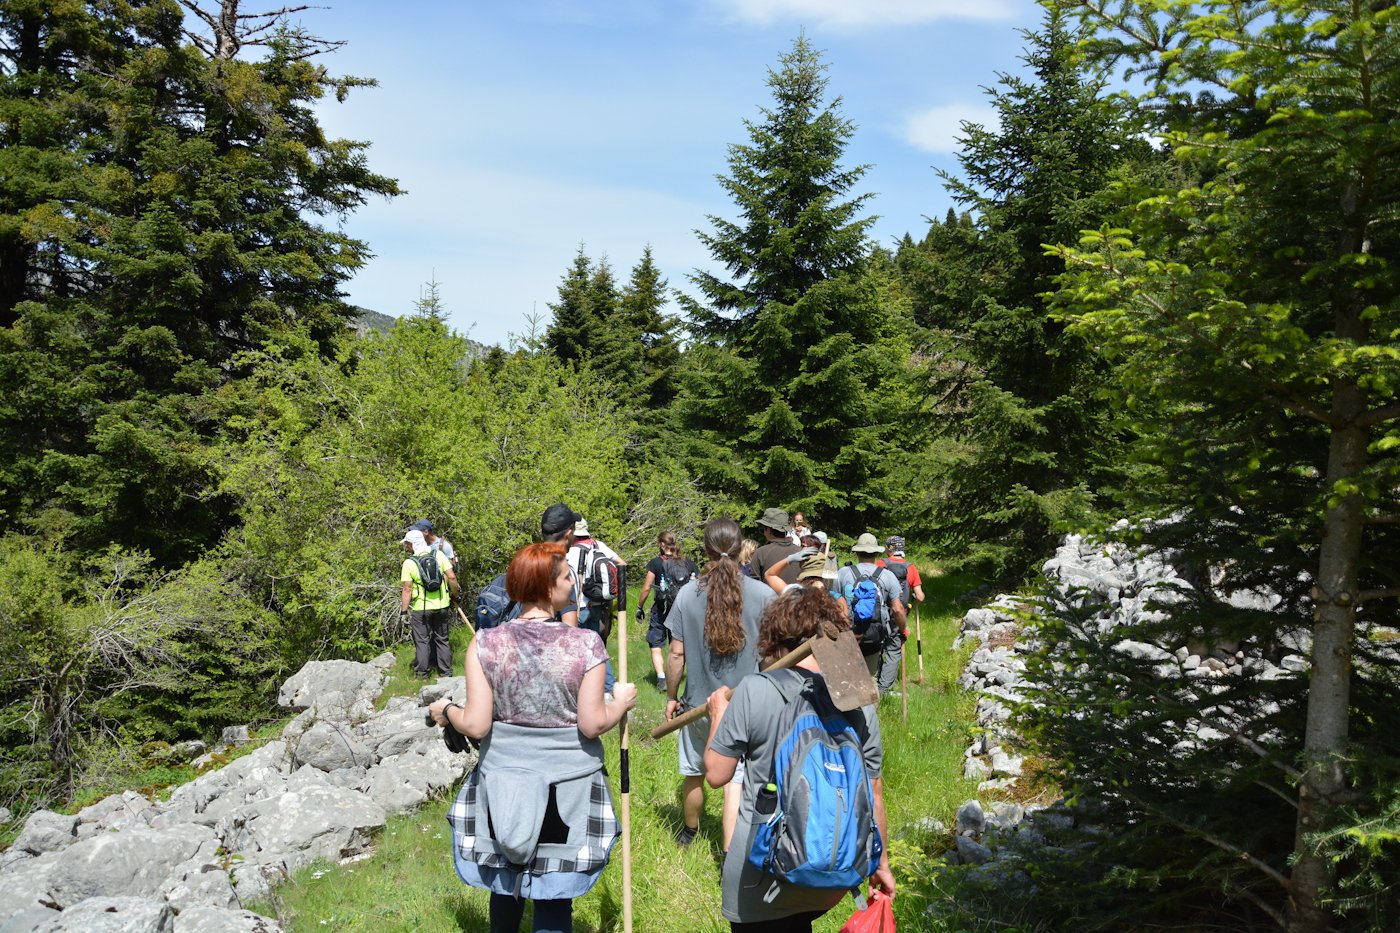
[666,516,785,850]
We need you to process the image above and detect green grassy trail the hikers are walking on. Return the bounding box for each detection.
[259,577,976,933]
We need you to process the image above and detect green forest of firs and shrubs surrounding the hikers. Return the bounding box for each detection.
[0,0,1400,932]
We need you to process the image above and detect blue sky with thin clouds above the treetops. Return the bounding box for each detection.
[309,0,1039,343]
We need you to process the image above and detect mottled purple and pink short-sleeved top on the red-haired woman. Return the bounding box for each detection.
[476,619,608,728]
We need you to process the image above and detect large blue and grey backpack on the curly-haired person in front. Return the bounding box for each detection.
[748,671,885,901]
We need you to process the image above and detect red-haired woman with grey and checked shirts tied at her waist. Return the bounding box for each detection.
[428,542,637,933]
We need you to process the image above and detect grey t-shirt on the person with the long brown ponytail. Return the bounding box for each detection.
[666,573,777,706]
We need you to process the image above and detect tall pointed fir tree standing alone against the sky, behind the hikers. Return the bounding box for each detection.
[678,36,904,528]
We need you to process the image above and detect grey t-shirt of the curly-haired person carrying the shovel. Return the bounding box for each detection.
[710,668,888,923]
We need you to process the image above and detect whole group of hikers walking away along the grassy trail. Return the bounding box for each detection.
[400,503,924,933]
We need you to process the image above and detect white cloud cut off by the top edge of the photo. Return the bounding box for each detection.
[717,0,1015,27]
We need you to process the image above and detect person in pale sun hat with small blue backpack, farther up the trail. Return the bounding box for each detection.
[836,531,907,696]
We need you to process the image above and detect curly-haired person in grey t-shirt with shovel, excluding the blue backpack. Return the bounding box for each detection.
[704,587,895,933]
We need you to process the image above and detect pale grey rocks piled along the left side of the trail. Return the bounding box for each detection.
[0,654,473,933]
